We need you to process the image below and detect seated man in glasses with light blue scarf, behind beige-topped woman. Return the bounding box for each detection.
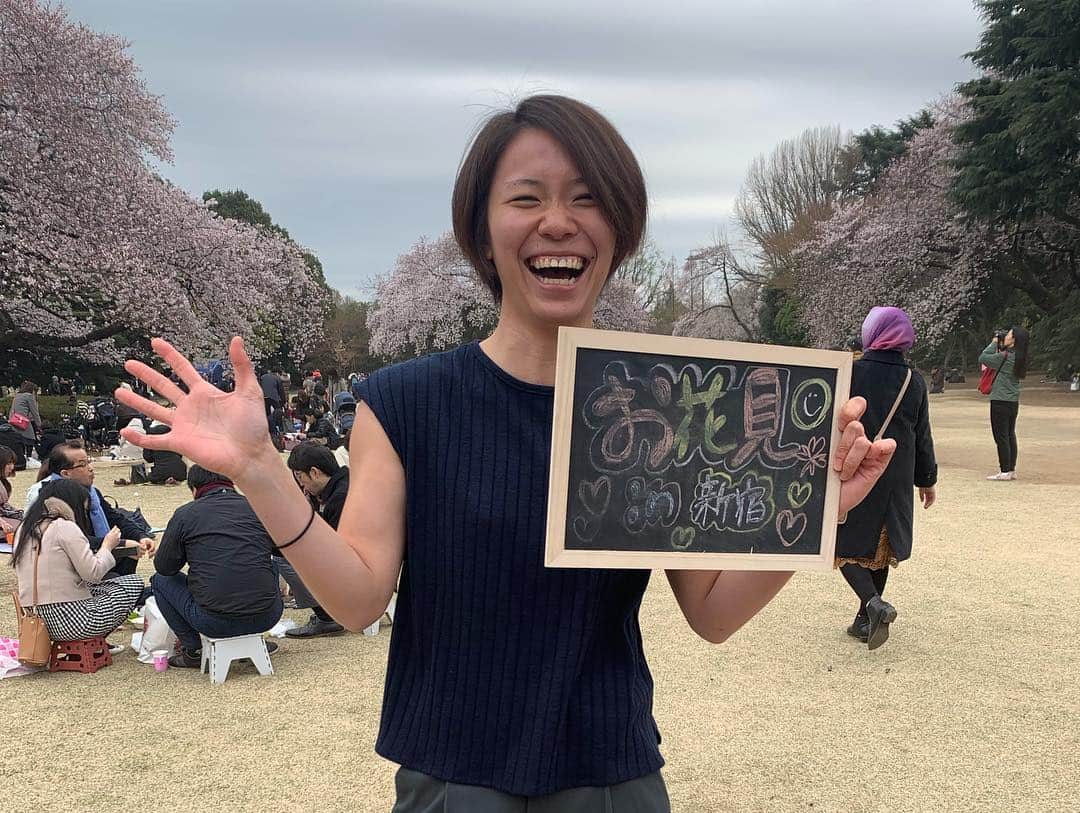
[26,441,154,575]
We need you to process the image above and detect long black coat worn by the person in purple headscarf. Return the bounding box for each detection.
[836,350,937,561]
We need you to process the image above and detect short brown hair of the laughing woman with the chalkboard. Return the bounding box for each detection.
[451,95,648,301]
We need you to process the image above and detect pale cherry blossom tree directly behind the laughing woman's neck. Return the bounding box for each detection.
[368,229,649,356]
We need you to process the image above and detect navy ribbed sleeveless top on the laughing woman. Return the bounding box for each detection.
[363,342,663,796]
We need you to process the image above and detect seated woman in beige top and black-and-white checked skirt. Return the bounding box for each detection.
[12,479,143,640]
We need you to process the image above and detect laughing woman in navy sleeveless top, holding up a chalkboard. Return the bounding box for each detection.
[117,96,894,813]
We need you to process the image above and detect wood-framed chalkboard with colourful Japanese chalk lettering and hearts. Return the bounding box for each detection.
[546,327,852,570]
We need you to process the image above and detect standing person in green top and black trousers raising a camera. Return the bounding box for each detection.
[978,325,1027,480]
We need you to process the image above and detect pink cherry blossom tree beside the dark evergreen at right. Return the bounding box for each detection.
[796,98,1007,347]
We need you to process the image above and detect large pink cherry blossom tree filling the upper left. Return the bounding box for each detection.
[0,0,323,363]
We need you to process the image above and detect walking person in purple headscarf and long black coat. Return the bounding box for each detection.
[836,308,937,649]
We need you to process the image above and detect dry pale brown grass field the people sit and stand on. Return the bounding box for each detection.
[0,384,1080,813]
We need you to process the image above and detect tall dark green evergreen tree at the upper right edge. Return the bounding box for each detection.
[951,0,1080,368]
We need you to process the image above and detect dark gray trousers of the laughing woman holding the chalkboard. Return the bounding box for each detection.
[391,768,672,813]
